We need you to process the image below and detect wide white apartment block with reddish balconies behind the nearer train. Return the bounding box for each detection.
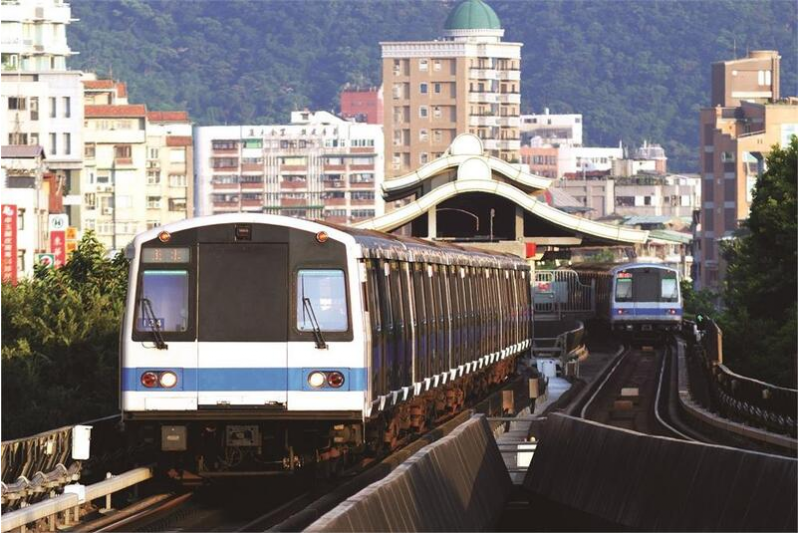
[195,111,383,224]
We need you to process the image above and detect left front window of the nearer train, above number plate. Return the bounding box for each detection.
[136,270,189,332]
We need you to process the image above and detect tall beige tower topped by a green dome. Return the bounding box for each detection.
[381,0,522,178]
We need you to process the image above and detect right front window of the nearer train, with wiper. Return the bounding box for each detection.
[297,269,347,331]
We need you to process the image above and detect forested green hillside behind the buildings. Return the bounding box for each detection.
[69,0,798,172]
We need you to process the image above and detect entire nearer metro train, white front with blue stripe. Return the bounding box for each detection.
[120,213,532,477]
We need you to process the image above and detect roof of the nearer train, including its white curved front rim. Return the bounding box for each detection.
[127,213,530,270]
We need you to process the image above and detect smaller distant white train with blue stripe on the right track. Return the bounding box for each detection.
[569,263,683,333]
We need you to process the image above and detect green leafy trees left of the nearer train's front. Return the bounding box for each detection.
[0,233,128,440]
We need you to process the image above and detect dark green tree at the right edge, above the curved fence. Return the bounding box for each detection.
[721,137,797,385]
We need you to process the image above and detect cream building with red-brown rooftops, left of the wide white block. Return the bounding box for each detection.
[80,78,194,250]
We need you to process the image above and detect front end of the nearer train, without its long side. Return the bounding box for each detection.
[120,214,367,474]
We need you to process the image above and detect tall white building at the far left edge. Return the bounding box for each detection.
[0,0,83,220]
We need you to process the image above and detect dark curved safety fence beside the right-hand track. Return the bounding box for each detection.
[685,320,797,439]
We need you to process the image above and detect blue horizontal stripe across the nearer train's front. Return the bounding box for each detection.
[122,367,367,392]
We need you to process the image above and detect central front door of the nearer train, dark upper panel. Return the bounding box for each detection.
[197,242,289,407]
